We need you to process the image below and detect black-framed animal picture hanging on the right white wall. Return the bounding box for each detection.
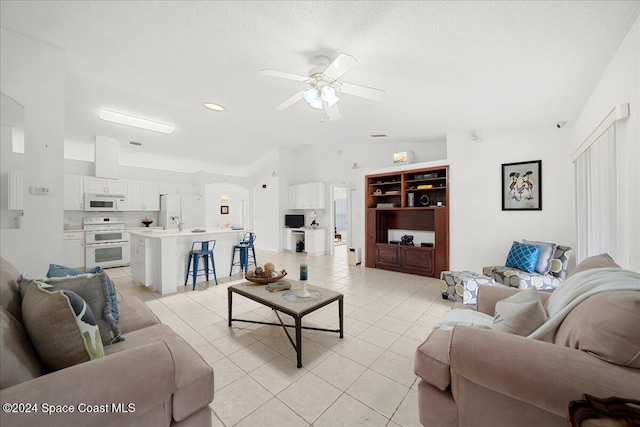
[500,160,542,211]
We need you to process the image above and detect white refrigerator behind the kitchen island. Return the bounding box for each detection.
[158,194,206,230]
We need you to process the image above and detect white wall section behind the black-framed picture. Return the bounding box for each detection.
[447,128,575,272]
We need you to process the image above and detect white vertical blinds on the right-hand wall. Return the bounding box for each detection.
[575,124,618,262]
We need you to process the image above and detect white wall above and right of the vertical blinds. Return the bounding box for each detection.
[571,18,640,271]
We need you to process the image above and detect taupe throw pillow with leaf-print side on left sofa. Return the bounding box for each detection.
[22,282,104,370]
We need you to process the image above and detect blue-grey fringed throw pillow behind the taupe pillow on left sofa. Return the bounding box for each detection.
[19,272,123,344]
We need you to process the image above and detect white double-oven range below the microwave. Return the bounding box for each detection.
[83,216,131,268]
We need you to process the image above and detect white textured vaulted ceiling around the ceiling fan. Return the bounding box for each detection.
[1,1,640,171]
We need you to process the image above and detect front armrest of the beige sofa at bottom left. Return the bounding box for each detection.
[0,342,176,426]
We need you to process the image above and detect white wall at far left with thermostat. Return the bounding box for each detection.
[0,28,65,276]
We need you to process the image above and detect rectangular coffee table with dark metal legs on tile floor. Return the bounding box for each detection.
[227,280,344,368]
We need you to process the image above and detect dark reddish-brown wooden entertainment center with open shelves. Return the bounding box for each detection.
[365,166,449,277]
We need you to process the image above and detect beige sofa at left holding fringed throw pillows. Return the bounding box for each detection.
[0,259,214,427]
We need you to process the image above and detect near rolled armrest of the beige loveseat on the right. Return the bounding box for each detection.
[449,326,640,417]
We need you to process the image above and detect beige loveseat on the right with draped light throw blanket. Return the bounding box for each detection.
[415,256,640,427]
